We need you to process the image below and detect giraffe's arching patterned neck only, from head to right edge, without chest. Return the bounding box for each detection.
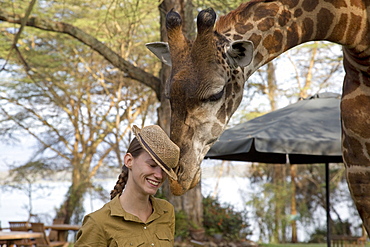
[216,0,370,78]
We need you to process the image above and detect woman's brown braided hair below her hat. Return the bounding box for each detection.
[110,137,144,200]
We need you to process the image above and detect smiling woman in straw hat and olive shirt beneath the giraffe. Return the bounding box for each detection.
[75,125,180,247]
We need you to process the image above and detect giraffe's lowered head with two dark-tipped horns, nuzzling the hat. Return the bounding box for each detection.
[147,9,253,195]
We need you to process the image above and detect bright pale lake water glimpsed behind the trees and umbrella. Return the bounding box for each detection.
[0,159,356,241]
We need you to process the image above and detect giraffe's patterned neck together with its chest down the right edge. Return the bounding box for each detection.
[216,0,370,233]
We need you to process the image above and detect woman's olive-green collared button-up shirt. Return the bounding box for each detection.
[74,196,175,247]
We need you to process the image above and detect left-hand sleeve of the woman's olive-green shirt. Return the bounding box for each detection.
[74,215,108,247]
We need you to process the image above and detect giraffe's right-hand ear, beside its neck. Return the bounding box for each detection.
[226,40,254,67]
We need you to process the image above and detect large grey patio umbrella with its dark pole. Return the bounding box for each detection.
[205,93,343,246]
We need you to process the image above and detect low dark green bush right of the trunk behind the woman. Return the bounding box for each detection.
[203,196,251,240]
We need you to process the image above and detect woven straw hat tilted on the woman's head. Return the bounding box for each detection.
[132,125,180,180]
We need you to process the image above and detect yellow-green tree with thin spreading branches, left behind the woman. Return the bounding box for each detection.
[0,1,159,223]
